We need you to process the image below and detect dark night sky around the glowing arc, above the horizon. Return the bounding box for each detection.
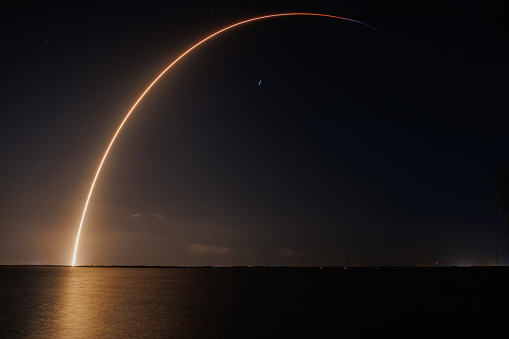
[0,0,509,266]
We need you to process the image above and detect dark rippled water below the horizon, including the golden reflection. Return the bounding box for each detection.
[0,267,509,338]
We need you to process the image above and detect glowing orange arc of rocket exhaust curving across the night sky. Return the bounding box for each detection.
[72,13,376,266]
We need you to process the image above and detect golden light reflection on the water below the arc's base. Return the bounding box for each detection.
[55,268,175,338]
